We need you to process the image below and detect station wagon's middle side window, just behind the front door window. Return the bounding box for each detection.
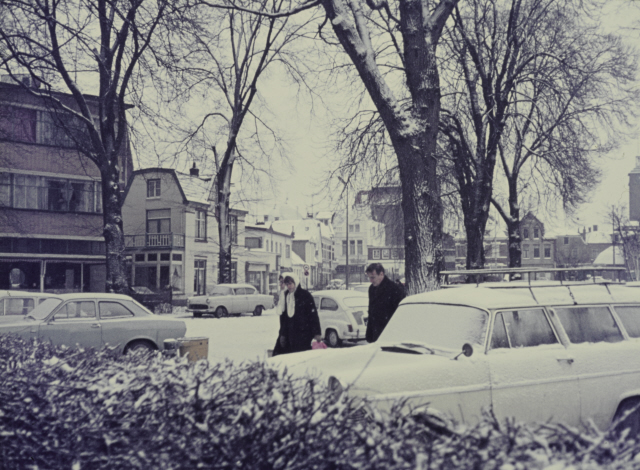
[554,306,623,344]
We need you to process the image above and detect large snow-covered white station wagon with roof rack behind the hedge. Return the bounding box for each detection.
[269,282,640,429]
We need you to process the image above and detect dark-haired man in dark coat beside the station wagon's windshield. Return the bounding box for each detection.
[366,263,404,343]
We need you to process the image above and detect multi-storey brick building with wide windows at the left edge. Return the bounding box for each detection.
[0,77,133,292]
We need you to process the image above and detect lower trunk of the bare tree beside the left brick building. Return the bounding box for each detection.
[100,162,129,294]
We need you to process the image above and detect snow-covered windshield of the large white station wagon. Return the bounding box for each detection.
[379,304,489,350]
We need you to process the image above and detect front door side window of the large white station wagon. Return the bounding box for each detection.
[491,309,558,349]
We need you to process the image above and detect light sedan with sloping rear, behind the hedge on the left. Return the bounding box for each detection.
[0,292,187,353]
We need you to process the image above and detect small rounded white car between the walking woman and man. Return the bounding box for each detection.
[312,290,369,348]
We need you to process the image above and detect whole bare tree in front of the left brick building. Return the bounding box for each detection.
[0,0,175,292]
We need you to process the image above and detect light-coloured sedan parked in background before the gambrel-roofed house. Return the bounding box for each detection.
[187,284,274,318]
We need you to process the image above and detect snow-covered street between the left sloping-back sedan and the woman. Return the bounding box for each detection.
[174,309,280,363]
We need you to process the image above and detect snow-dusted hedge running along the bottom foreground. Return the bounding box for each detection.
[0,336,640,470]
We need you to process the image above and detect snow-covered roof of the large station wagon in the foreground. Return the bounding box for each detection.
[401,283,640,310]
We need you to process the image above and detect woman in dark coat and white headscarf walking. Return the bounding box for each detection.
[274,273,322,355]
